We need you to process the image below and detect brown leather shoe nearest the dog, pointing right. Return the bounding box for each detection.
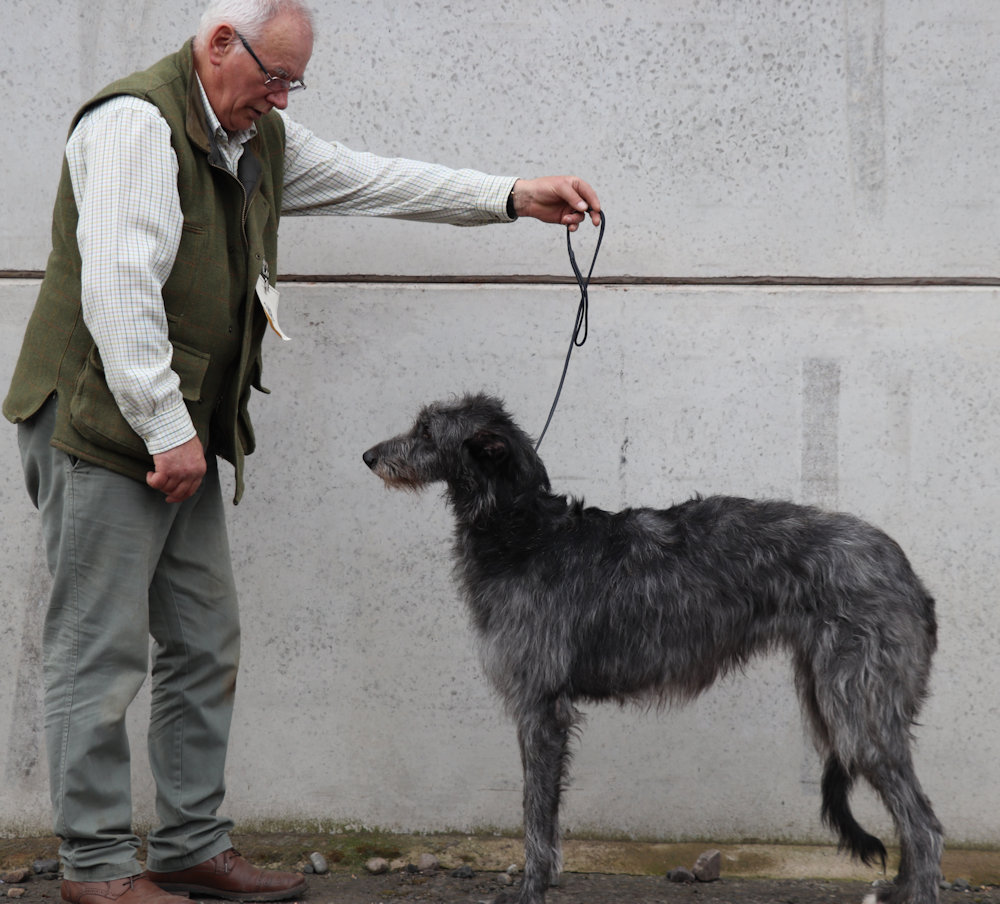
[146,848,306,904]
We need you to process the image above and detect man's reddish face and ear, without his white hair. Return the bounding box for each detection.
[213,14,312,132]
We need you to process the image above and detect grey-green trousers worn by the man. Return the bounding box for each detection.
[18,398,239,881]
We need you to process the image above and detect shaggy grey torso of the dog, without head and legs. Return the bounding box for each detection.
[456,490,936,716]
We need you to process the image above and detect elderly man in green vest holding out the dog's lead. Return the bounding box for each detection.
[4,0,600,904]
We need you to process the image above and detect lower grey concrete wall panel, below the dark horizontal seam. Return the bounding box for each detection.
[0,281,1000,844]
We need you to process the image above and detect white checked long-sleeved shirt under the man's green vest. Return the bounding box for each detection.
[66,83,515,455]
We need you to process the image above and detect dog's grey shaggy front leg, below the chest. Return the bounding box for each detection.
[498,696,579,904]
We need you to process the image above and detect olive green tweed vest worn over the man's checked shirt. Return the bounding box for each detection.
[3,42,285,502]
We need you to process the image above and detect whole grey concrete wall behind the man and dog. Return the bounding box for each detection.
[0,0,1000,844]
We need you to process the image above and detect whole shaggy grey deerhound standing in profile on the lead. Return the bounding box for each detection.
[364,395,942,904]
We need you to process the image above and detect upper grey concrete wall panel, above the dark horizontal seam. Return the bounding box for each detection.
[0,0,1000,277]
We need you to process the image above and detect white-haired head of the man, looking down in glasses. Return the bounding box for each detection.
[194,0,313,132]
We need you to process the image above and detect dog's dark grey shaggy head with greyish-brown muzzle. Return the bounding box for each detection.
[364,393,549,514]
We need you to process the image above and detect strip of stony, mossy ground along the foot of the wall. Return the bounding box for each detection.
[0,832,1000,904]
